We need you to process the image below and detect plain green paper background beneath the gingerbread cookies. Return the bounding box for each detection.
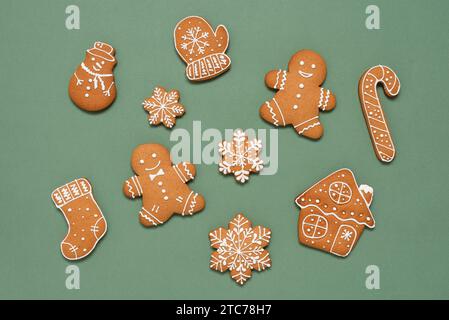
[0,0,449,299]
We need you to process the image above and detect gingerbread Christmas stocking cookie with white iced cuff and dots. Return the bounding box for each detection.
[51,178,107,260]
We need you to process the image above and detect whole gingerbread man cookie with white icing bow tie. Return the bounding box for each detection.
[123,144,205,227]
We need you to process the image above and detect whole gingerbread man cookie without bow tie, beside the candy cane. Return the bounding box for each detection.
[259,50,335,139]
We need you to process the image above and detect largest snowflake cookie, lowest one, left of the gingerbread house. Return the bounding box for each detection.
[209,213,271,285]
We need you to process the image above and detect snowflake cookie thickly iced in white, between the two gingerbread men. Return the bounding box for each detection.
[218,129,263,183]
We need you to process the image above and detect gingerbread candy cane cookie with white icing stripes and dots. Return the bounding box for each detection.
[359,65,401,162]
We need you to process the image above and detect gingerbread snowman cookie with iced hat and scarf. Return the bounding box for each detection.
[69,41,117,111]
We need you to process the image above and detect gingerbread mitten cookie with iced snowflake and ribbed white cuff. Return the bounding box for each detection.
[174,16,231,81]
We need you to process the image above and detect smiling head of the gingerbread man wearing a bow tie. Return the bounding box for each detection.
[131,144,171,175]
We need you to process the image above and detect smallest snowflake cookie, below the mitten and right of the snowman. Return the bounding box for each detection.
[142,87,185,128]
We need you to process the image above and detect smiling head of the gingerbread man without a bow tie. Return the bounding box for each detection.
[288,50,326,85]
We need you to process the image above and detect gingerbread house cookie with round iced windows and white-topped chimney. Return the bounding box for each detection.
[295,169,375,257]
